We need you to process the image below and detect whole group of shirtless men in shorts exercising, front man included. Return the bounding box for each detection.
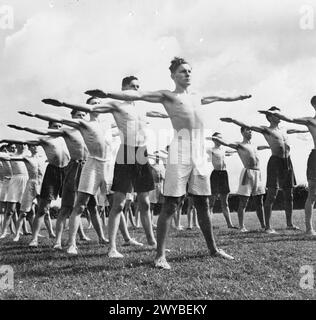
[0,57,316,269]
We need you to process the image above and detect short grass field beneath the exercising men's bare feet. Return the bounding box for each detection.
[0,211,316,300]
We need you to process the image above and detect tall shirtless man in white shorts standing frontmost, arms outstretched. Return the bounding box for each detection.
[86,58,248,269]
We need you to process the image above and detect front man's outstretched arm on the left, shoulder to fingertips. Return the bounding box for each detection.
[85,89,167,103]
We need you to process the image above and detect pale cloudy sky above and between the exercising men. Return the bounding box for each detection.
[0,0,316,191]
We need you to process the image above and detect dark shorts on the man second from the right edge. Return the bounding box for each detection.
[267,156,296,189]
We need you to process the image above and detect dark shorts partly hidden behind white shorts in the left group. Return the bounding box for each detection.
[61,160,96,207]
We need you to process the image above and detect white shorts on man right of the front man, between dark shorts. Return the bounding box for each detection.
[237,168,266,197]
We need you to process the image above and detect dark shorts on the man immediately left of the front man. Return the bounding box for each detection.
[112,145,155,193]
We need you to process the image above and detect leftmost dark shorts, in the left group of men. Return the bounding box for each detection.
[40,164,67,201]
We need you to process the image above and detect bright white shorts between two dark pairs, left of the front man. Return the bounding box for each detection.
[78,157,113,196]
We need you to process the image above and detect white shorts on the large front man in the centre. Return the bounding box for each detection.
[164,140,211,197]
